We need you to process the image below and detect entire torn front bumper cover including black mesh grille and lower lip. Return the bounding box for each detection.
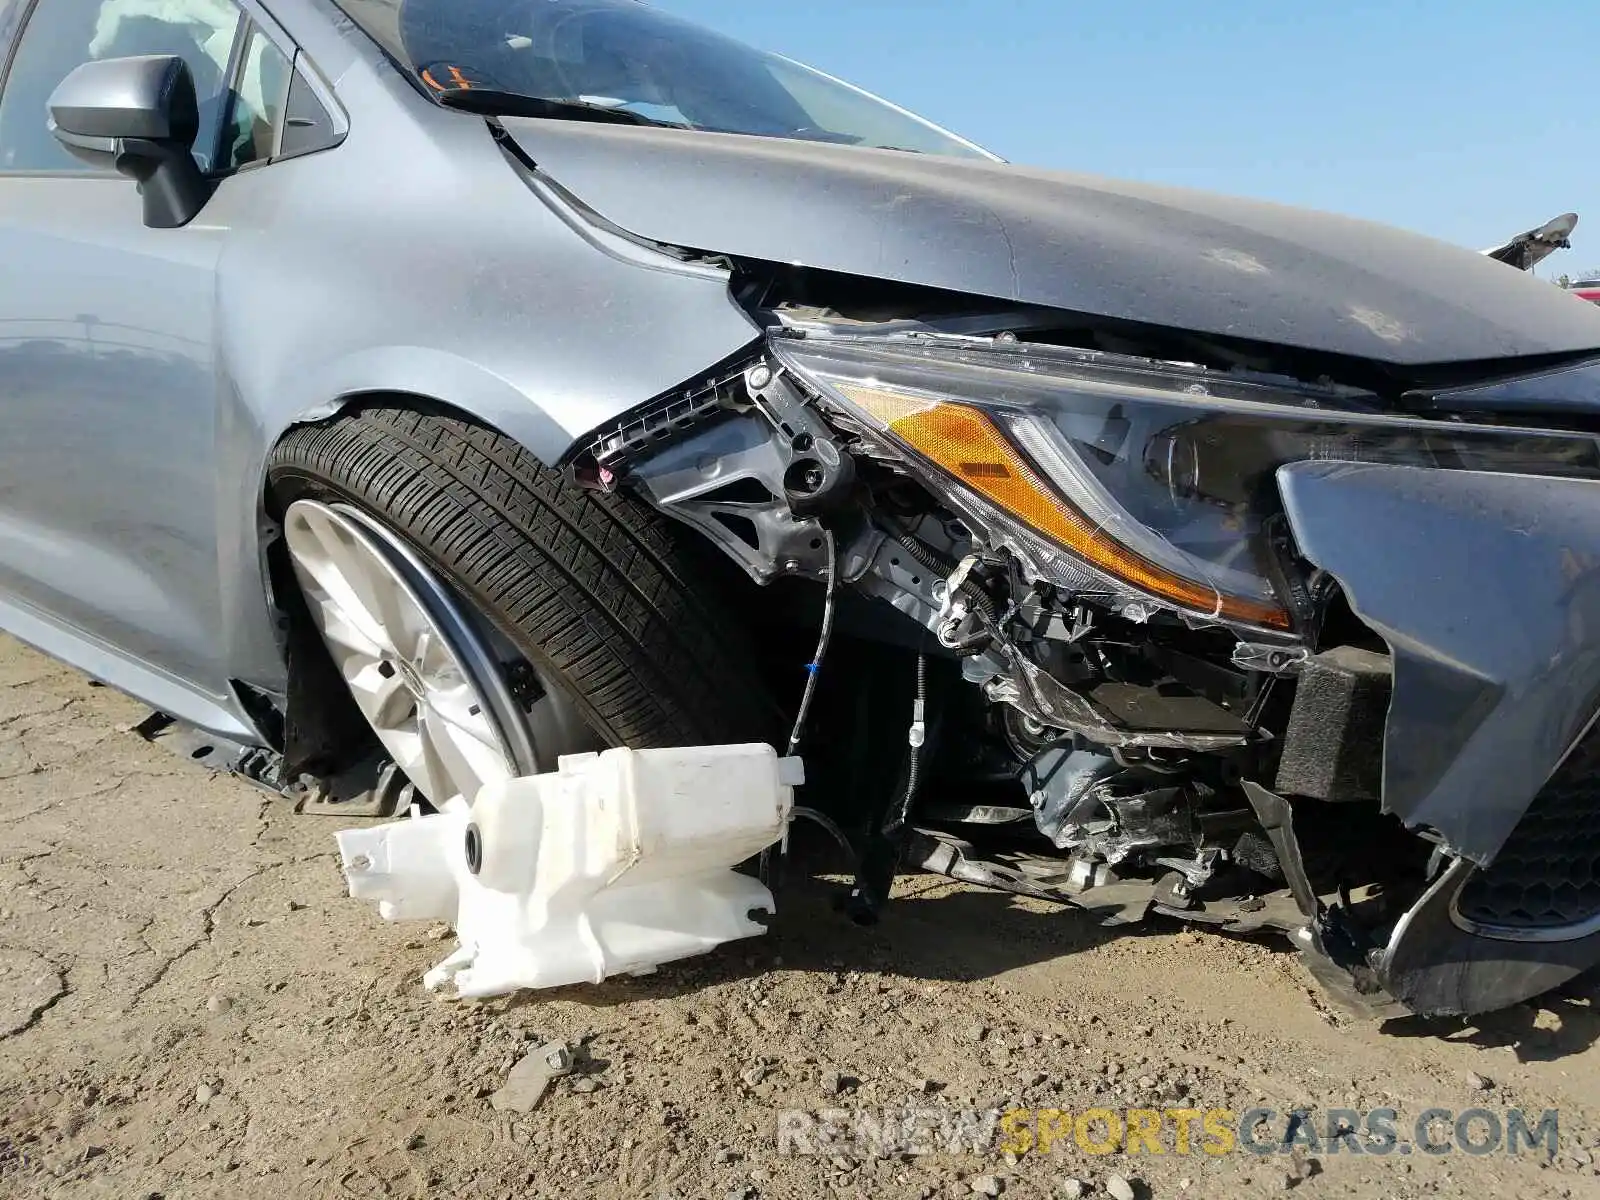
[1278,462,1600,1013]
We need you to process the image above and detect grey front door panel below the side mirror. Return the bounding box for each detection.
[0,176,227,731]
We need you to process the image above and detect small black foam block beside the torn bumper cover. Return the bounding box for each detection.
[1277,646,1392,800]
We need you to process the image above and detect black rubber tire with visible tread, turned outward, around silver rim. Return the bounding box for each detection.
[269,403,778,770]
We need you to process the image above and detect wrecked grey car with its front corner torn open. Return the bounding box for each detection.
[0,0,1600,1013]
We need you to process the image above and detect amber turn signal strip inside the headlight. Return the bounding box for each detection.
[834,384,1290,629]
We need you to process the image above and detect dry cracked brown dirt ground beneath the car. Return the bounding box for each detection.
[0,640,1600,1200]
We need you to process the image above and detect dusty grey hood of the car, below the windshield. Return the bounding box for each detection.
[504,118,1600,365]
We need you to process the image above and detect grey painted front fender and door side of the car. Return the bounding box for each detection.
[0,0,757,736]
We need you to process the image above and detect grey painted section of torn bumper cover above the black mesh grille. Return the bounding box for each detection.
[1277,462,1600,866]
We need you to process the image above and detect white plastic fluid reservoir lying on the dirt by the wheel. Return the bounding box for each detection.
[338,746,803,997]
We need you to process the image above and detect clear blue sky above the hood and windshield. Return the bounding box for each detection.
[654,0,1600,275]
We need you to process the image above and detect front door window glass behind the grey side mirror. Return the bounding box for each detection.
[0,0,243,173]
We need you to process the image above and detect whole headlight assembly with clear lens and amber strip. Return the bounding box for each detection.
[773,336,1600,634]
